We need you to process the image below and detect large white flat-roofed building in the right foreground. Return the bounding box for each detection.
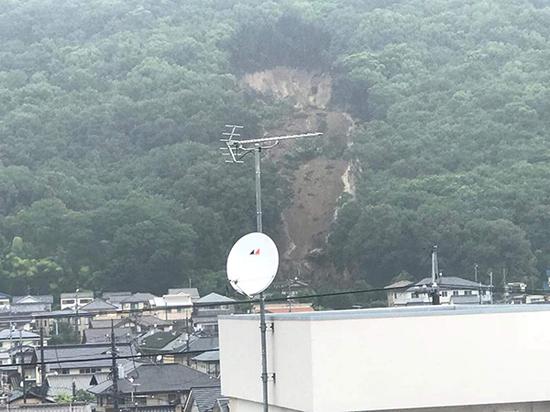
[220,305,550,412]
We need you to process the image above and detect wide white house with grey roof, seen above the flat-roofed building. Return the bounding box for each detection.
[386,276,492,306]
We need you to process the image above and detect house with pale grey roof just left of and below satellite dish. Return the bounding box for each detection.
[192,293,235,334]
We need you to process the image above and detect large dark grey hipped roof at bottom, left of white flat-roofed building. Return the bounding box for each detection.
[89,363,219,395]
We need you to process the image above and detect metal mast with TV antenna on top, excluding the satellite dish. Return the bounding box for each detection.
[220,125,322,412]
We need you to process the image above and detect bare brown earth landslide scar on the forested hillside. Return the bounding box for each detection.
[242,67,354,284]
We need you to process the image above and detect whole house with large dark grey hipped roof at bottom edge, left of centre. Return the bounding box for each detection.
[89,364,219,412]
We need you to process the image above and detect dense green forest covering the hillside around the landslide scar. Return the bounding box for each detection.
[0,0,550,293]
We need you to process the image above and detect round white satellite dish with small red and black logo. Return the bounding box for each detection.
[227,232,279,296]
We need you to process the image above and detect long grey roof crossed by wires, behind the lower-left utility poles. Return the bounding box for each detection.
[44,344,136,369]
